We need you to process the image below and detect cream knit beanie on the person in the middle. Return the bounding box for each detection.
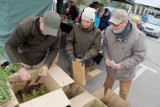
[82,7,95,22]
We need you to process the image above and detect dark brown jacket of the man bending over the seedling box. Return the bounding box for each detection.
[5,17,61,67]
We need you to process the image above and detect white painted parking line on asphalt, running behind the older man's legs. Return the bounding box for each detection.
[114,64,157,94]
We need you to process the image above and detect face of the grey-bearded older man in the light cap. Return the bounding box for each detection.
[111,20,128,33]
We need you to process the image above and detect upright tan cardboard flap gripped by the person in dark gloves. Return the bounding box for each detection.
[72,59,86,86]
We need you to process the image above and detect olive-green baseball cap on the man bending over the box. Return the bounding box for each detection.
[43,11,61,36]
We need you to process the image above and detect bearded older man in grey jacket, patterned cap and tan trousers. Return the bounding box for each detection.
[104,9,146,100]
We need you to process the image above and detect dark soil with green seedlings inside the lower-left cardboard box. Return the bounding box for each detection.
[15,83,49,103]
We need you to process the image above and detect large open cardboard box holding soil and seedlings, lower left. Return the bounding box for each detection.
[7,65,74,107]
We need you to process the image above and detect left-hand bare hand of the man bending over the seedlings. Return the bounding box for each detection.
[18,68,31,81]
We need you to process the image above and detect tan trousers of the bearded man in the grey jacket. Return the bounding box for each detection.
[104,74,132,100]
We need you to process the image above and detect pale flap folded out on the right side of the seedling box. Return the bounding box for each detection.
[49,65,74,87]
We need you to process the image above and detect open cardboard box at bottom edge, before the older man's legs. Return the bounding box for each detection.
[92,87,130,107]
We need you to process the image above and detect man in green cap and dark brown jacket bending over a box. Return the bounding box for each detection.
[5,11,61,80]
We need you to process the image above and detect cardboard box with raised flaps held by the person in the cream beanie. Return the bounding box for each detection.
[72,59,102,86]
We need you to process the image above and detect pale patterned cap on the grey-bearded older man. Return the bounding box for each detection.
[109,9,128,25]
